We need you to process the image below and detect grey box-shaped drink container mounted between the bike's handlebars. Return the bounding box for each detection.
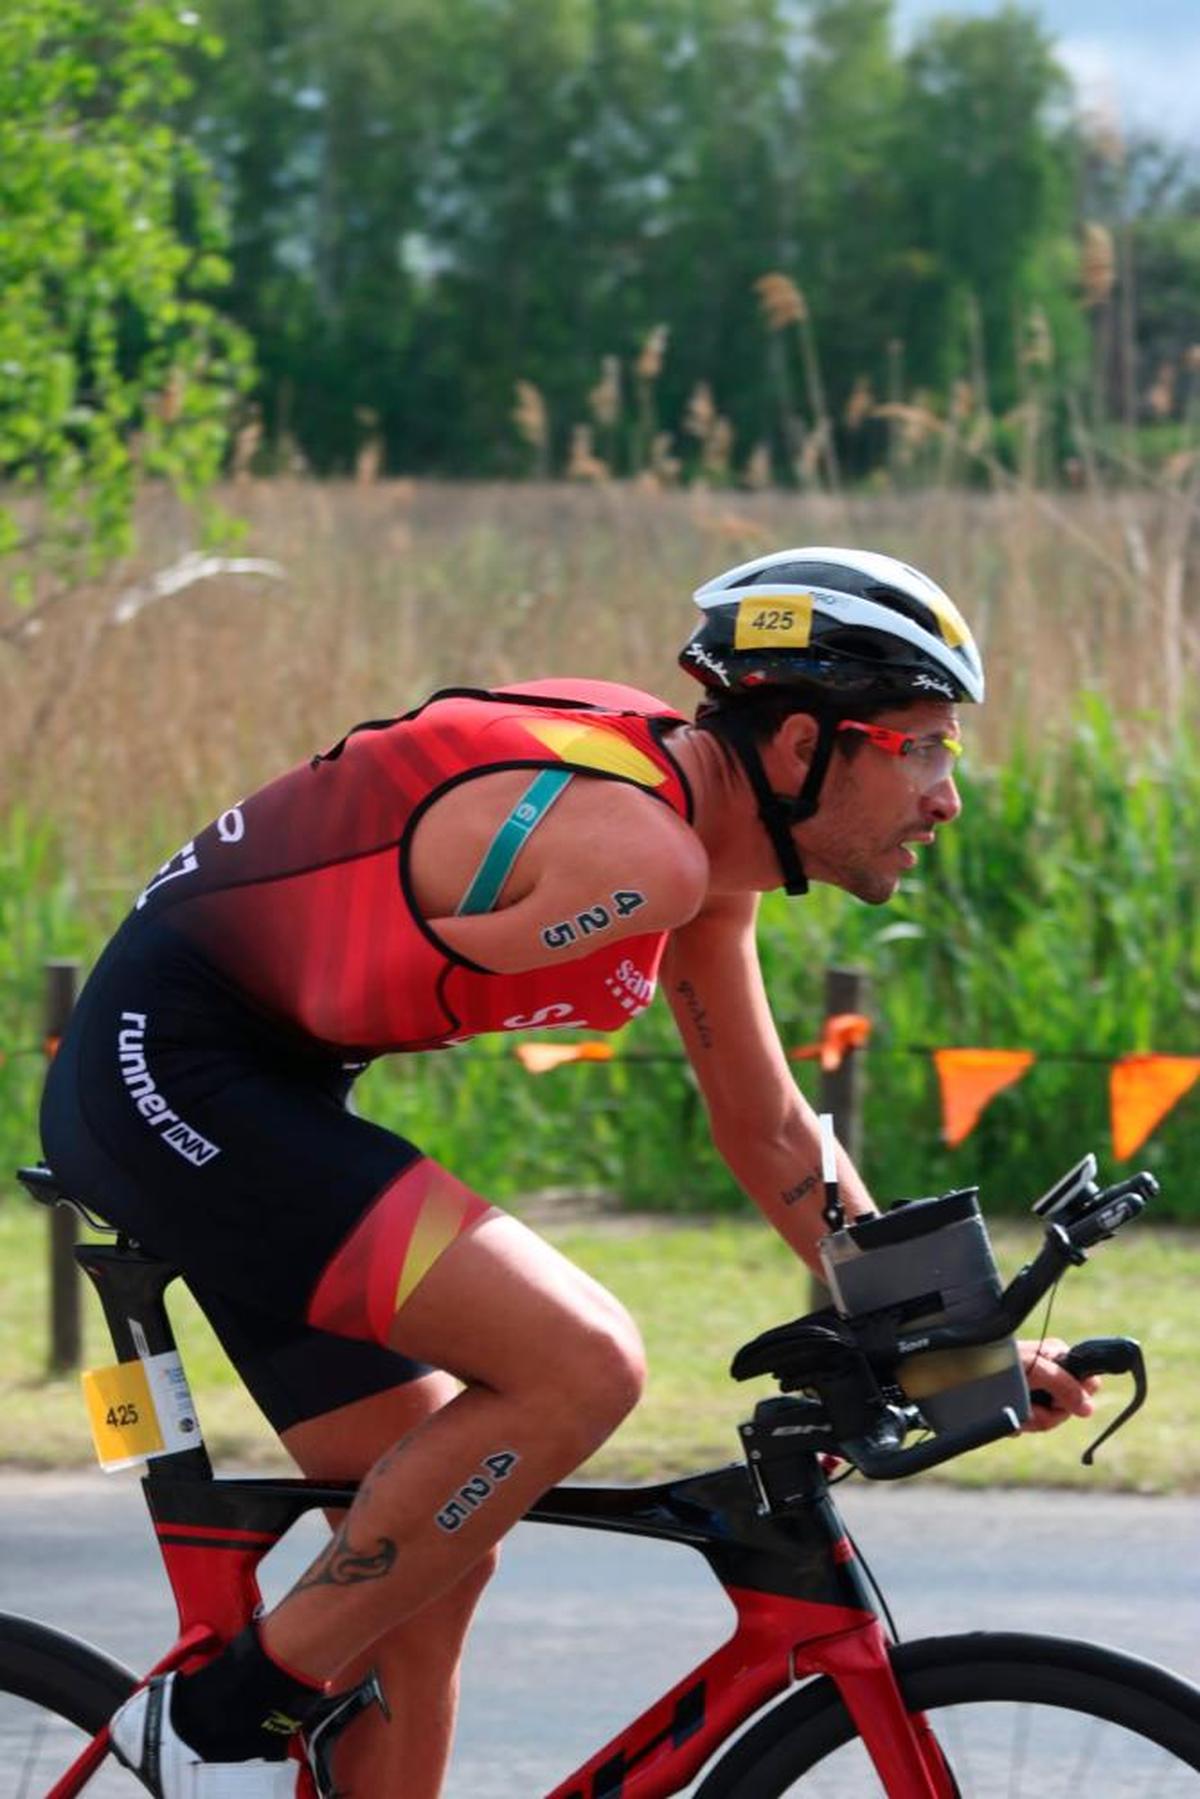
[819,1187,1029,1432]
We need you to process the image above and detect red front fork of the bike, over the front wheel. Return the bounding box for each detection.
[795,1617,961,1799]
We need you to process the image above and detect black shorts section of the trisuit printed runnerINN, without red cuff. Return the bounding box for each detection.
[41,917,471,1430]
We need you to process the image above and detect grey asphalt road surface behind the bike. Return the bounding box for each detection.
[0,1475,1200,1799]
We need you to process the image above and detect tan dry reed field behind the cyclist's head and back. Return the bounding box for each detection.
[0,478,1200,880]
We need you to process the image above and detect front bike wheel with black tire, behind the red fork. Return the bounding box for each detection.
[696,1632,1200,1799]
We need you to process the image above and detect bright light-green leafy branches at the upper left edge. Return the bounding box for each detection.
[0,0,246,600]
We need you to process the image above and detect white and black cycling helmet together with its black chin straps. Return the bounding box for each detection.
[680,547,984,894]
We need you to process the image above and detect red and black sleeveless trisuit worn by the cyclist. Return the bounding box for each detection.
[41,680,691,1430]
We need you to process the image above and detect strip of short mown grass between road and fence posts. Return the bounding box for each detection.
[0,1198,1200,1493]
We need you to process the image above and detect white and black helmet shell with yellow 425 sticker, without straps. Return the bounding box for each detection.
[680,547,984,707]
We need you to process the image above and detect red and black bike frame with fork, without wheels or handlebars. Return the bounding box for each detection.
[47,1245,957,1799]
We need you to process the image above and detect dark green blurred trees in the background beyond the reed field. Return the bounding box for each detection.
[185,0,1101,473]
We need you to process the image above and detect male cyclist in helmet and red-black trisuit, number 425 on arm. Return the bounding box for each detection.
[43,549,1092,1799]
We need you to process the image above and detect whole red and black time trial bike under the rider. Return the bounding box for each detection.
[0,1157,1200,1799]
